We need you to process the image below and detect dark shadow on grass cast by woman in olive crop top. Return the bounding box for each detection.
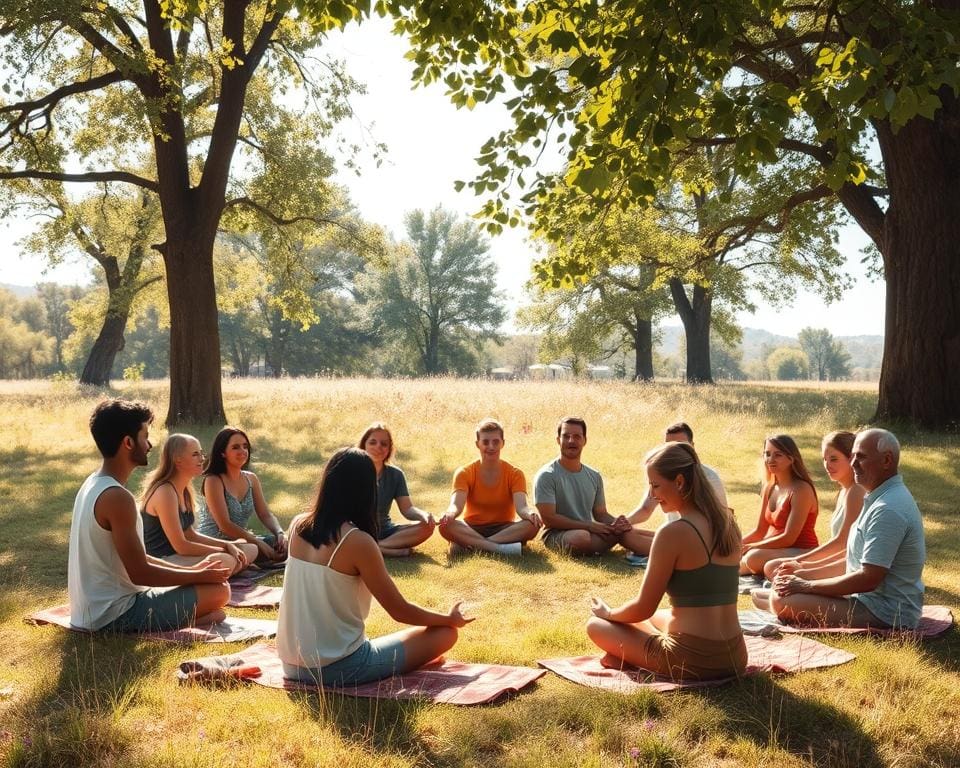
[700,672,884,768]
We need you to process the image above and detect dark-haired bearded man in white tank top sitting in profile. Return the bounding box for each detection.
[67,400,230,632]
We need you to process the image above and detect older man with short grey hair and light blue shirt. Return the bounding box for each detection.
[770,429,927,629]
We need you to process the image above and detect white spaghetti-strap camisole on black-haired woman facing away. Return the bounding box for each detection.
[277,528,370,668]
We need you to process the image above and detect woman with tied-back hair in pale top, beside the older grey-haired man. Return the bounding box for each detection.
[752,432,866,609]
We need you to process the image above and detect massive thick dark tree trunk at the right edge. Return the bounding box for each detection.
[877,96,960,428]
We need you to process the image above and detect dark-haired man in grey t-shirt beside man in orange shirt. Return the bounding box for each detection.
[533,416,638,555]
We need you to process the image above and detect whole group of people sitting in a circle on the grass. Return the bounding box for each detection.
[68,400,926,685]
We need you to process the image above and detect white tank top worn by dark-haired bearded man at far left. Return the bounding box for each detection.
[67,472,146,630]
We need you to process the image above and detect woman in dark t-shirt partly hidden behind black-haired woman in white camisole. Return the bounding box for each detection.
[357,422,437,557]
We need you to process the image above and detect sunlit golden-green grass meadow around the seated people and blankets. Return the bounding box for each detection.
[0,379,960,768]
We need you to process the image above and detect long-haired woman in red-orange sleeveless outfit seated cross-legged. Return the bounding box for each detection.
[740,435,820,576]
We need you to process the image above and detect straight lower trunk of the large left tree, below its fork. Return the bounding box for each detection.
[163,234,227,426]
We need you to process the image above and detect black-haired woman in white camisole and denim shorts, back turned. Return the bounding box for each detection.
[277,448,473,686]
